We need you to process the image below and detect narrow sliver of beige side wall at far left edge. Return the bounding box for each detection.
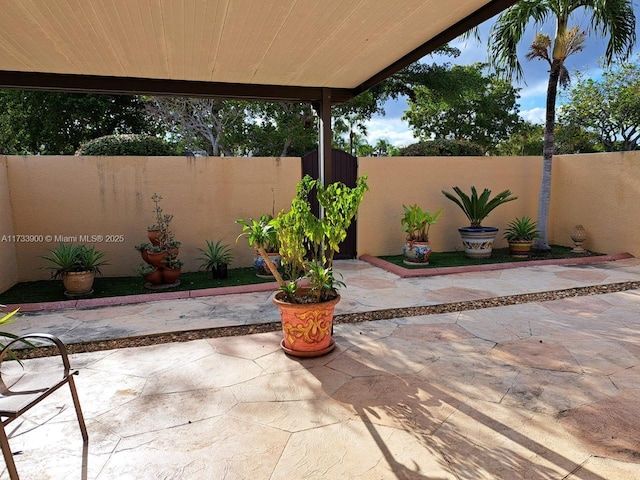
[0,156,18,292]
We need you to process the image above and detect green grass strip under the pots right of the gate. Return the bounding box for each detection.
[380,245,601,269]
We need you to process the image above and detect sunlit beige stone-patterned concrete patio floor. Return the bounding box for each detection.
[0,258,640,480]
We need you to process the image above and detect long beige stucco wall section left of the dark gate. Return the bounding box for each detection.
[5,156,301,283]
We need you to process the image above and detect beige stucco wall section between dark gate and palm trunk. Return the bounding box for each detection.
[358,157,553,255]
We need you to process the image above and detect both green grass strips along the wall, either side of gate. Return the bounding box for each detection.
[0,246,598,304]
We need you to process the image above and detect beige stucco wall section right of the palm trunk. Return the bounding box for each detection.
[551,151,640,257]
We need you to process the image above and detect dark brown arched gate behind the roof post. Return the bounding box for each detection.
[302,148,358,259]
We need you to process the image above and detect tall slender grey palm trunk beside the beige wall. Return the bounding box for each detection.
[534,60,562,251]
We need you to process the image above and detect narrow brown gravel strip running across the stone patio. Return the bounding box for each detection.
[19,281,640,359]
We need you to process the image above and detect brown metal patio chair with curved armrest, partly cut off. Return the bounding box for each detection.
[0,333,89,480]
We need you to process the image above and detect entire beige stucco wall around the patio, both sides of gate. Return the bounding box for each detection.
[0,152,640,291]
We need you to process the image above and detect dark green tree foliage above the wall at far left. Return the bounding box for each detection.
[0,90,156,155]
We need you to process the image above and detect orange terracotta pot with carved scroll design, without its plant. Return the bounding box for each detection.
[273,292,340,357]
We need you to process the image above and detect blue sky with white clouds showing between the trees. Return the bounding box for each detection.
[367,3,640,146]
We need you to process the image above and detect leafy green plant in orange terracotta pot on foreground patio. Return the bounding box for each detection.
[242,175,368,357]
